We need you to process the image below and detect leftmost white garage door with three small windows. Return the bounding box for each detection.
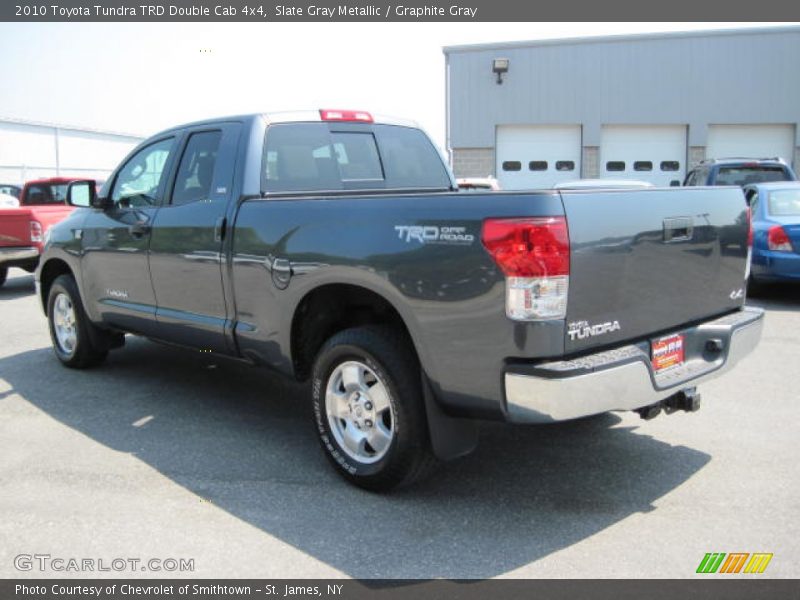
[495,125,581,190]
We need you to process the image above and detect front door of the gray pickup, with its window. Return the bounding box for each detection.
[81,136,176,335]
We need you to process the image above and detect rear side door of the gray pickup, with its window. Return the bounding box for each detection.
[150,123,241,353]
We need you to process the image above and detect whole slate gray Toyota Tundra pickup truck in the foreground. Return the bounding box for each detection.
[37,110,763,490]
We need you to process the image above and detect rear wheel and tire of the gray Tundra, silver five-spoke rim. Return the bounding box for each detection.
[312,327,436,491]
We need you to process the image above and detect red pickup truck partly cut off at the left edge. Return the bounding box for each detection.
[0,177,81,286]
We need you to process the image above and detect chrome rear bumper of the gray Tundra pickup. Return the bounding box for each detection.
[505,307,764,423]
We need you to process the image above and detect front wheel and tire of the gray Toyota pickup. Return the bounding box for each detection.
[47,275,108,369]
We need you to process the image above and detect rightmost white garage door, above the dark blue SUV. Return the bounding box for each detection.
[706,125,794,164]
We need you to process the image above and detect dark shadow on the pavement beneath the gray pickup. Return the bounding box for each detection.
[0,337,710,579]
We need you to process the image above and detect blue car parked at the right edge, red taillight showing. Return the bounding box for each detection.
[744,181,800,286]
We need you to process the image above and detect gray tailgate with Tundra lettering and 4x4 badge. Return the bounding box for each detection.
[561,187,748,353]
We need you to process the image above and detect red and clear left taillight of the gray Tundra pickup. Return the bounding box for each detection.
[481,217,569,321]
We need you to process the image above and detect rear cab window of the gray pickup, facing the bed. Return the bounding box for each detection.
[264,123,450,192]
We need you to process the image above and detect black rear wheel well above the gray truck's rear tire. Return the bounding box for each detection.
[291,284,414,381]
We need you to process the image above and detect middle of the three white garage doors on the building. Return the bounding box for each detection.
[599,125,686,186]
